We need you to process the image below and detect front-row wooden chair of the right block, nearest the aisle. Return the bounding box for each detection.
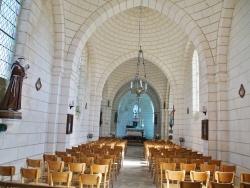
[163,170,185,188]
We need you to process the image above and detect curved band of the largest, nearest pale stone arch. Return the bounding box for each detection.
[66,0,214,86]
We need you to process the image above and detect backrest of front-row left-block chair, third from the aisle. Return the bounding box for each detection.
[20,168,41,183]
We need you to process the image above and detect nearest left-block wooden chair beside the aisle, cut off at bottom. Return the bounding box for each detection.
[79,174,102,188]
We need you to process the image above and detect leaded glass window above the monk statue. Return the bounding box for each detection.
[0,0,22,79]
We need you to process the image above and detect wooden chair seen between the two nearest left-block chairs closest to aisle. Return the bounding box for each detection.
[68,163,86,186]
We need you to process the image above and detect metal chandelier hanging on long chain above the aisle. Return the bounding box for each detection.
[130,6,147,98]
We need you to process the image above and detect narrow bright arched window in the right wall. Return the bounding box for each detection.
[192,50,200,112]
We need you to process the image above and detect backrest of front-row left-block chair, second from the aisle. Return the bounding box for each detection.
[50,171,72,187]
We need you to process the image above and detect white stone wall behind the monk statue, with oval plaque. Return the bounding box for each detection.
[0,0,54,178]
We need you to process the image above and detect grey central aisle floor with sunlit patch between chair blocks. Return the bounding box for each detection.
[114,145,155,188]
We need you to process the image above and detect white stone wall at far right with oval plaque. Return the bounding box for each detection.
[228,0,250,172]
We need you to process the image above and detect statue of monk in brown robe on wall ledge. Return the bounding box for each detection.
[0,58,29,112]
